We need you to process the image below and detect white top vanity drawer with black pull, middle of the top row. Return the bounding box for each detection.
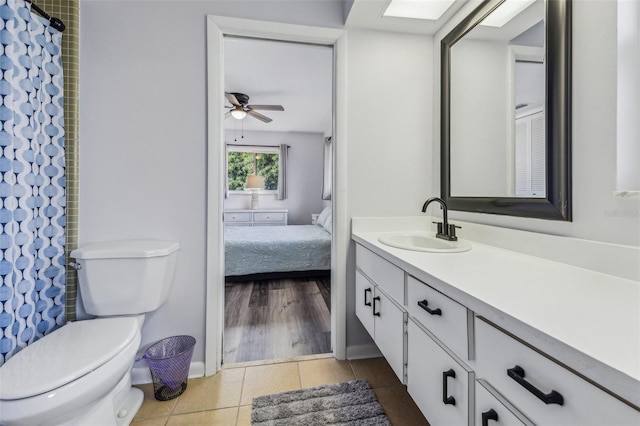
[407,276,470,359]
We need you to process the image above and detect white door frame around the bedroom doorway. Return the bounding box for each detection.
[204,15,350,376]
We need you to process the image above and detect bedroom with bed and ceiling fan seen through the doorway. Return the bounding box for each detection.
[222,36,334,364]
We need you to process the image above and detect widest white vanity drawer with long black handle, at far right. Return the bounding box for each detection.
[475,319,640,426]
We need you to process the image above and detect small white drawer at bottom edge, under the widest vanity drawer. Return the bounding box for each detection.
[476,379,534,426]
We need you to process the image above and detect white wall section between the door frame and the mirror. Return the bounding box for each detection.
[346,30,433,347]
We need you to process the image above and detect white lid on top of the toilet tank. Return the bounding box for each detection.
[71,240,180,259]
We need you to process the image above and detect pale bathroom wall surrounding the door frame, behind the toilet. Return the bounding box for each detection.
[79,1,433,362]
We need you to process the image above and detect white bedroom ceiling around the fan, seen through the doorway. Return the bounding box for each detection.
[224,37,333,134]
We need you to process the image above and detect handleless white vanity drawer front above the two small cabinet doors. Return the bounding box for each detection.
[356,244,404,304]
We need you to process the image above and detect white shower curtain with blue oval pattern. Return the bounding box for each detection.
[0,0,65,365]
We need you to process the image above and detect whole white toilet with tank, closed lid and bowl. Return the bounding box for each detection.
[0,240,180,426]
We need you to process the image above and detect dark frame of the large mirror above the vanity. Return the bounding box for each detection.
[440,0,571,221]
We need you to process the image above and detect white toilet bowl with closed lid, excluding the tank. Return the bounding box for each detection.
[0,316,144,426]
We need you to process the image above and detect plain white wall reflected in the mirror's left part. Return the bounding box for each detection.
[450,40,513,197]
